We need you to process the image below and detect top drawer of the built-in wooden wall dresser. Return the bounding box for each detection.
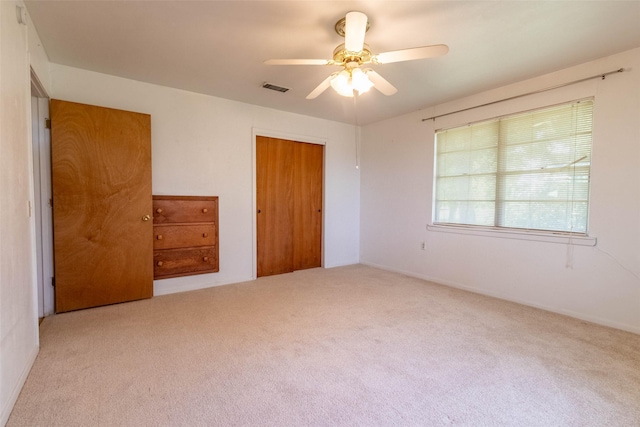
[153,196,218,224]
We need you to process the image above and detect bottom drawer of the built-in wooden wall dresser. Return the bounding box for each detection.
[153,247,218,279]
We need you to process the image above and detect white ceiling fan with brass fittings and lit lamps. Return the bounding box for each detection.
[264,11,449,99]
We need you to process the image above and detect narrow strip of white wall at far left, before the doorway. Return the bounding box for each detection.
[0,1,46,425]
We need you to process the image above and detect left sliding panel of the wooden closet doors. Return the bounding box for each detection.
[256,136,293,277]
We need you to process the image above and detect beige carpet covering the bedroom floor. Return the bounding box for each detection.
[8,265,640,427]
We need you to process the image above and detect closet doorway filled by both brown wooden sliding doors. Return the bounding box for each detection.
[256,136,324,277]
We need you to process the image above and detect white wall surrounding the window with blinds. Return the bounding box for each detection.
[360,49,640,333]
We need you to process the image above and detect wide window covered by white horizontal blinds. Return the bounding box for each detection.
[434,99,593,235]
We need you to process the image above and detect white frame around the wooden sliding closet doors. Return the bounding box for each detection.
[251,127,328,280]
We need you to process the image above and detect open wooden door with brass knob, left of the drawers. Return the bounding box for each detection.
[51,100,153,312]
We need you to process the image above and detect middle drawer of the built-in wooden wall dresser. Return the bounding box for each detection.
[153,224,216,249]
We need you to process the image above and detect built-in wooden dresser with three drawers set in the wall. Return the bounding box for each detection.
[153,196,219,279]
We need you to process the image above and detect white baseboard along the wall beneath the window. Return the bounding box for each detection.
[360,261,640,335]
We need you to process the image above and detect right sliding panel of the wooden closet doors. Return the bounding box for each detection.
[293,143,324,270]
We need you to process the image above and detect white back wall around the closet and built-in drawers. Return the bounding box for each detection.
[51,64,360,295]
